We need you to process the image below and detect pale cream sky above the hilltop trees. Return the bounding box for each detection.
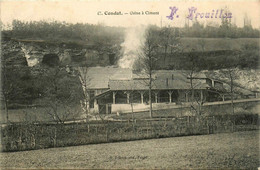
[0,0,260,28]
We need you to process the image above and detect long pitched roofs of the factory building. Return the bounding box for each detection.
[87,67,209,90]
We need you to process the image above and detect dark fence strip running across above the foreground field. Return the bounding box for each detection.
[1,115,258,151]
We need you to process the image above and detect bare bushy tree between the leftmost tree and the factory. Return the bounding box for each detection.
[36,67,79,124]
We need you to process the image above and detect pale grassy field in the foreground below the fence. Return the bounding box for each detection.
[0,131,259,169]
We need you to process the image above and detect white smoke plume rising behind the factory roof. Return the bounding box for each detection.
[118,26,146,69]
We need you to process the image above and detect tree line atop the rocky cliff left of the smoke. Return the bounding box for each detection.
[3,20,123,43]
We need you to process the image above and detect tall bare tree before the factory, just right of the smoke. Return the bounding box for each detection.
[135,26,159,118]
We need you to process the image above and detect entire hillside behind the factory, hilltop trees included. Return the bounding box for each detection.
[2,20,260,70]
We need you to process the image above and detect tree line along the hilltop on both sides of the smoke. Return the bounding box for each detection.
[4,20,260,40]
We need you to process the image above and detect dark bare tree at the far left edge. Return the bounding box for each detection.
[1,41,33,122]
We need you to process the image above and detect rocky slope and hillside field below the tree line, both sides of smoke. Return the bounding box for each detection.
[2,38,259,70]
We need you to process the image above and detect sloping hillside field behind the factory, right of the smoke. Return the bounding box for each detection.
[158,38,260,70]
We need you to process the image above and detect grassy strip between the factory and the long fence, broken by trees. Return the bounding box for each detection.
[0,99,260,123]
